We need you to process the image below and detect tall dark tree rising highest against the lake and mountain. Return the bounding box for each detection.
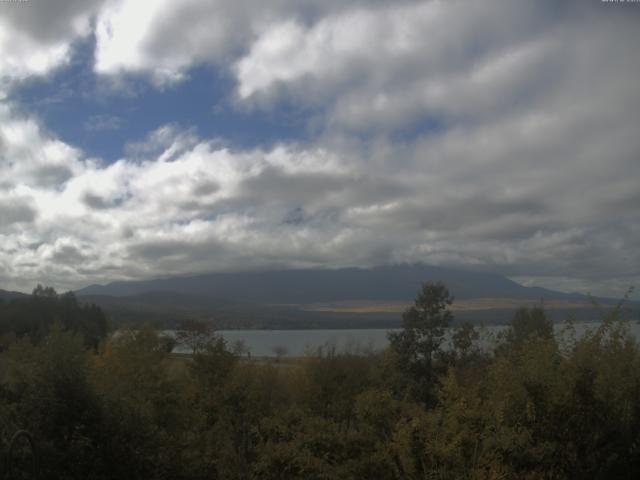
[389,282,453,402]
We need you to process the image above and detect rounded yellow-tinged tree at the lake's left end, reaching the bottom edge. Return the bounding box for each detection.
[92,324,189,480]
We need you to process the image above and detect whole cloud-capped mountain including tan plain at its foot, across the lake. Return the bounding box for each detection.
[76,264,624,329]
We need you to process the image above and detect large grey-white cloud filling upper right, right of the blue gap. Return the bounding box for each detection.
[235,1,638,132]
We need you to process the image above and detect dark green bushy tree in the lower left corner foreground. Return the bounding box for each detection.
[0,323,102,478]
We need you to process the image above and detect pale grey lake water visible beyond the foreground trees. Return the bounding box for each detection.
[169,322,640,357]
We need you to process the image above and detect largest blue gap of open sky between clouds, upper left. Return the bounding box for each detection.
[11,36,310,163]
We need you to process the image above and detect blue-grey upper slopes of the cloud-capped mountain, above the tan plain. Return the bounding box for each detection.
[76,265,585,304]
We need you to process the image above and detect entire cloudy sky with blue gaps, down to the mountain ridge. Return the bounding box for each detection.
[0,0,640,299]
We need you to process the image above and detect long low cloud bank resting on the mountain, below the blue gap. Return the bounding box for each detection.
[0,117,640,292]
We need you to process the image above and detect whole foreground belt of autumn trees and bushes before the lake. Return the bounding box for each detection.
[0,283,640,480]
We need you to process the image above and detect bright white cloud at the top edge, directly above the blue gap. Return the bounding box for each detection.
[95,0,396,83]
